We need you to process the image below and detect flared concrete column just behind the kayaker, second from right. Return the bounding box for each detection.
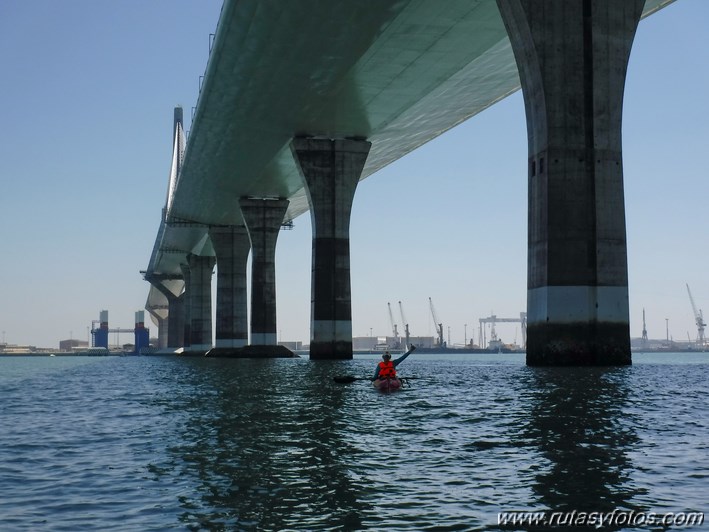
[291,138,371,359]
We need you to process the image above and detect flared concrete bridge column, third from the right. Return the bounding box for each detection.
[239,198,289,346]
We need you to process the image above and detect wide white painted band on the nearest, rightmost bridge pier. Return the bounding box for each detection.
[527,286,630,325]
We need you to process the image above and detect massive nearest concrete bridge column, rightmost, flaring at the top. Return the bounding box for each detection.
[497,0,645,365]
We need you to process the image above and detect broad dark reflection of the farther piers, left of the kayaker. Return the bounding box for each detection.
[160,360,364,529]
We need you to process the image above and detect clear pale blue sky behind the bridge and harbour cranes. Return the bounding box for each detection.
[0,0,709,347]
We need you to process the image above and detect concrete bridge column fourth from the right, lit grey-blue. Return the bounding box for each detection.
[209,225,250,348]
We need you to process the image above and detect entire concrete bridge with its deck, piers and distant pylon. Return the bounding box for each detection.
[142,0,672,365]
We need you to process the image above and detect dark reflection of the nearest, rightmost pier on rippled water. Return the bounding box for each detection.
[525,368,646,512]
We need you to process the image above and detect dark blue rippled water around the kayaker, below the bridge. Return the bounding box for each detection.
[0,354,709,531]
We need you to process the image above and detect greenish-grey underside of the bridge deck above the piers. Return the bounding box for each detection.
[142,0,671,308]
